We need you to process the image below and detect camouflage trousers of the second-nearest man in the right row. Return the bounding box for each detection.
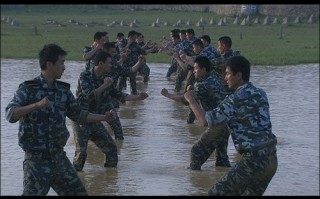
[190,125,231,170]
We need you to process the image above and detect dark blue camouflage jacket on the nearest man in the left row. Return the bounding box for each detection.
[6,75,88,151]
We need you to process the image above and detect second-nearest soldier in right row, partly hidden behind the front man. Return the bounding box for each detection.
[161,56,231,170]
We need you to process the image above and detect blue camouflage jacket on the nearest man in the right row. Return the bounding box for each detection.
[205,82,277,154]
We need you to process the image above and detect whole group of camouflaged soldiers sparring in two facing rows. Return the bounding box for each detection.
[6,29,277,195]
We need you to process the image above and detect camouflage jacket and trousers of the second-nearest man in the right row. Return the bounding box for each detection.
[182,74,231,170]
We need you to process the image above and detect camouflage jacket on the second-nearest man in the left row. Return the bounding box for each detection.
[76,68,128,114]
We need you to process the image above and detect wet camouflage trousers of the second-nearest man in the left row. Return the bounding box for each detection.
[72,122,118,171]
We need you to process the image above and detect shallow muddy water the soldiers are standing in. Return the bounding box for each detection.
[1,59,319,196]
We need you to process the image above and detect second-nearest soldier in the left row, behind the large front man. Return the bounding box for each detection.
[72,51,148,171]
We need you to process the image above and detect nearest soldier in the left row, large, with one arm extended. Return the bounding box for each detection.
[6,44,115,195]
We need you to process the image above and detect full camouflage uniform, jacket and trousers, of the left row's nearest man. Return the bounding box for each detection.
[6,75,89,195]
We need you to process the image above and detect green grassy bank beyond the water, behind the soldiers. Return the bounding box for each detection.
[1,5,319,65]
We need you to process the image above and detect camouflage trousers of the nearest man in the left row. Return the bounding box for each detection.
[23,150,88,196]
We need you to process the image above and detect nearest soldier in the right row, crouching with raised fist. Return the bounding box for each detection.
[184,55,278,196]
